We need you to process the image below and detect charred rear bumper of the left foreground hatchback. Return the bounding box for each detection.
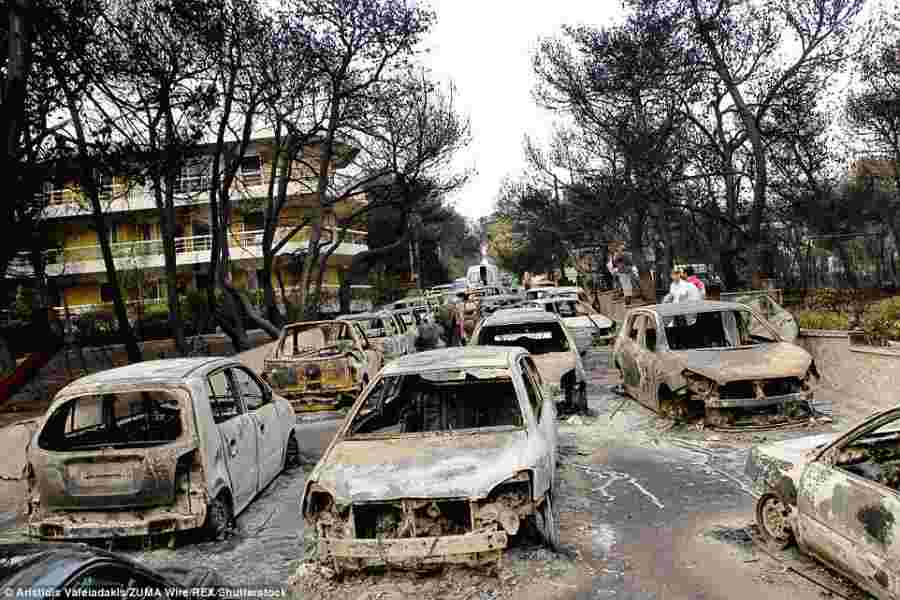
[28,510,206,540]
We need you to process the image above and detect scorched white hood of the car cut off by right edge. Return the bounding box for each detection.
[744,433,839,496]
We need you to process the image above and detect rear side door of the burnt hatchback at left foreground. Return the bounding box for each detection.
[206,365,260,515]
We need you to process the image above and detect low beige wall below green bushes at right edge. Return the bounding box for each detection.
[796,329,900,411]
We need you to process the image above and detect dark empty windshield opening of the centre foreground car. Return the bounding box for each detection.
[348,376,524,437]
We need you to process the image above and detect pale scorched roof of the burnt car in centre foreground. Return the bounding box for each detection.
[382,346,528,375]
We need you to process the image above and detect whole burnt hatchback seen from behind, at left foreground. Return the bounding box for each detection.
[26,358,299,539]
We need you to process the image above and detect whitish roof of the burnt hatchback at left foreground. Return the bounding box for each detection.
[63,356,234,393]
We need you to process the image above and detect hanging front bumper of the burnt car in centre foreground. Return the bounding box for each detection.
[319,529,508,568]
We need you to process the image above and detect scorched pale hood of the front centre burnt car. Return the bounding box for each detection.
[310,429,528,504]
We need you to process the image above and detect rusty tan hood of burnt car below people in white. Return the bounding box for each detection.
[675,342,812,385]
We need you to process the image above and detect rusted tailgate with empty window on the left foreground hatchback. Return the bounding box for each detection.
[29,389,195,510]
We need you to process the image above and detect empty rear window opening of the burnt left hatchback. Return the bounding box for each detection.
[38,391,182,451]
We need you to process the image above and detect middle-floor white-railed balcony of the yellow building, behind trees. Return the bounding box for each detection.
[47,227,369,277]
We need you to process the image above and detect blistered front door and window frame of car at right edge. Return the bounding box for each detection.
[794,409,900,598]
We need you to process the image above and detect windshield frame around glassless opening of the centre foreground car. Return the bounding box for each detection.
[335,367,528,443]
